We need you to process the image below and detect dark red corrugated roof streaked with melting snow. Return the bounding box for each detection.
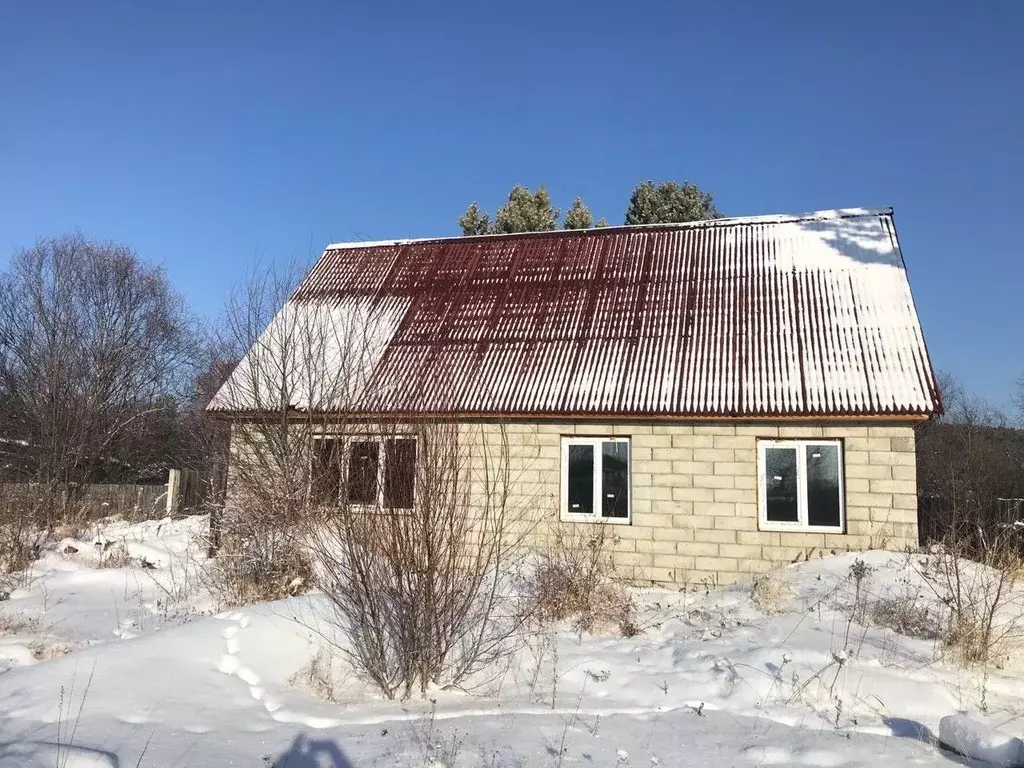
[215,209,938,418]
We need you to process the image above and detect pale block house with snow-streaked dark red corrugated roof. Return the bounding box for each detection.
[211,209,940,586]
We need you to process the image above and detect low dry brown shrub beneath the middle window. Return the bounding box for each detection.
[527,523,639,637]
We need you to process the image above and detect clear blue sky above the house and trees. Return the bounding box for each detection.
[0,0,1024,402]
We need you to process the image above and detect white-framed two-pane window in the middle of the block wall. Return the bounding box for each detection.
[560,437,633,524]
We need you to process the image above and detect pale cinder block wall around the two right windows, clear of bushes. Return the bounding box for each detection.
[485,423,918,588]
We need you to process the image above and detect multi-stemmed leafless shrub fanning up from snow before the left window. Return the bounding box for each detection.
[309,422,529,698]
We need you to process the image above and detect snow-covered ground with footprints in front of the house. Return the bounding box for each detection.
[0,517,1024,768]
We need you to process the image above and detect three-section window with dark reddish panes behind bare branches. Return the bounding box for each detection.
[317,435,416,509]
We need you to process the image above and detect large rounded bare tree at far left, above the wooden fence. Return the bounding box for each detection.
[0,234,195,518]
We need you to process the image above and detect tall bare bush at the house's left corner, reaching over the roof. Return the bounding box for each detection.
[201,264,372,603]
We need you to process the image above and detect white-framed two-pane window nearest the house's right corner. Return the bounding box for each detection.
[758,439,846,534]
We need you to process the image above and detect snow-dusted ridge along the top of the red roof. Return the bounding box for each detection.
[324,207,893,252]
